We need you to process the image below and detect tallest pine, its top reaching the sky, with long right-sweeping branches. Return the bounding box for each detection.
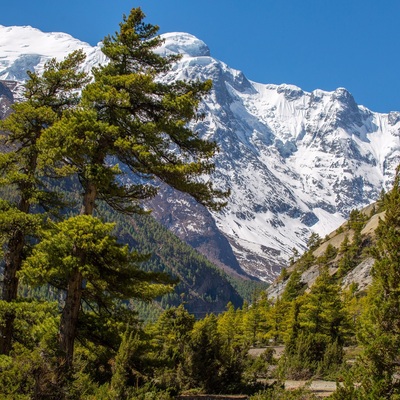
[33,8,227,376]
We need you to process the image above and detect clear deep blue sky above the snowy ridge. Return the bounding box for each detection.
[0,0,400,112]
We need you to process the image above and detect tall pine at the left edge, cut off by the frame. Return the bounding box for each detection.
[0,51,88,354]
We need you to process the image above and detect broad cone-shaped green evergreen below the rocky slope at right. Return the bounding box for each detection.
[283,268,350,379]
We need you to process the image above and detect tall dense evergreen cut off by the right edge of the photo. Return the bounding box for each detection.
[356,169,400,399]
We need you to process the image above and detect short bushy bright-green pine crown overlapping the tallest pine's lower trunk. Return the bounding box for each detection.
[22,215,173,380]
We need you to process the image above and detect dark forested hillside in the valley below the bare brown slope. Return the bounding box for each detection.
[104,206,266,317]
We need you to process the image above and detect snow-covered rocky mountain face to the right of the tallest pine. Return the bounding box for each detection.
[153,34,400,279]
